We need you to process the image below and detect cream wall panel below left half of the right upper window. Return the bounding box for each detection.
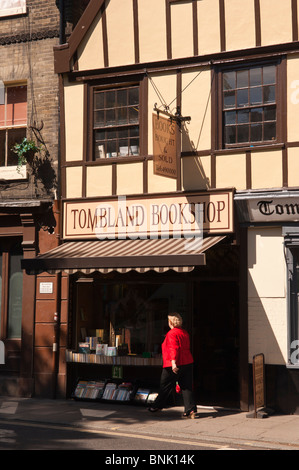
[216,154,246,190]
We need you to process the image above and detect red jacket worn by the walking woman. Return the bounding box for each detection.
[162,328,193,367]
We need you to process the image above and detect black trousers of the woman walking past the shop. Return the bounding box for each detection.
[153,364,196,413]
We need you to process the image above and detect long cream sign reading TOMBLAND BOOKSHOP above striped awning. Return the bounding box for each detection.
[63,190,233,239]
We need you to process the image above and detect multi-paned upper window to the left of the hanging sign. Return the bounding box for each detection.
[93,86,139,160]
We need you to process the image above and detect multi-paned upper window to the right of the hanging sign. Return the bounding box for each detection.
[222,65,278,148]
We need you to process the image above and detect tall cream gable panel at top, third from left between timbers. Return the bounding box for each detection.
[138,0,167,62]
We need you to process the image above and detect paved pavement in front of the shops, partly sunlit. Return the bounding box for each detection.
[0,397,299,450]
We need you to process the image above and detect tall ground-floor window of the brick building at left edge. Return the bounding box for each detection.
[0,243,23,339]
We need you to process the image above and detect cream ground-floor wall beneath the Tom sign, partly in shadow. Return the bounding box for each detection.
[248,228,287,364]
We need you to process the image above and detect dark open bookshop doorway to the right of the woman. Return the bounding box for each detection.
[193,280,240,408]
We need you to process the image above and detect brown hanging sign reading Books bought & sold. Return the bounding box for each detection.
[153,113,177,179]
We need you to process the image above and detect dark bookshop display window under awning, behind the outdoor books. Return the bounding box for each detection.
[73,280,190,358]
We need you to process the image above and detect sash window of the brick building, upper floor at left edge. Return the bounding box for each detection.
[0,85,27,166]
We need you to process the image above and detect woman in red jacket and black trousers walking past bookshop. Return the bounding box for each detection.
[149,313,197,419]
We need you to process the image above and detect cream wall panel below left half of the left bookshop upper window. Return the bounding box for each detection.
[86,165,112,197]
